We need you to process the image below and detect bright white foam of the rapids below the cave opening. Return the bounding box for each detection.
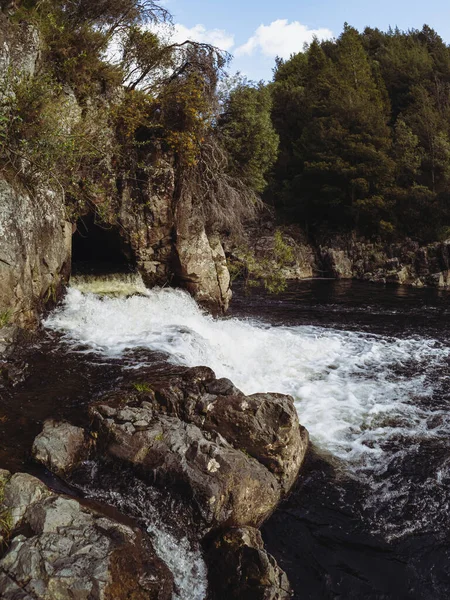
[45,289,450,536]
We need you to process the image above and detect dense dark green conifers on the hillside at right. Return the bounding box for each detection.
[266,25,450,242]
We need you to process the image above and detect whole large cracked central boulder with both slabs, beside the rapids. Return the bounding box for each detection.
[90,367,308,528]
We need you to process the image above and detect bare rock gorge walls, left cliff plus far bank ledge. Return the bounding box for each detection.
[0,13,450,327]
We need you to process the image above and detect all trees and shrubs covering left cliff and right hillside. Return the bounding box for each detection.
[0,0,450,242]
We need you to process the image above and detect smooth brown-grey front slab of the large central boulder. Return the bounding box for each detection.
[91,404,280,527]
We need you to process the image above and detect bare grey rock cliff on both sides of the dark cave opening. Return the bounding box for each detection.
[0,13,231,327]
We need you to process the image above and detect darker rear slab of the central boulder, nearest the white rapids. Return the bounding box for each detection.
[132,367,309,493]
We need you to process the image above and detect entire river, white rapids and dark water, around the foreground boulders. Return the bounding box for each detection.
[0,280,450,600]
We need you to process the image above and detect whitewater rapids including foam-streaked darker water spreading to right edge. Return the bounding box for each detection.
[41,280,450,548]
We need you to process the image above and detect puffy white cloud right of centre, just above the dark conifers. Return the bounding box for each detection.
[235,19,333,59]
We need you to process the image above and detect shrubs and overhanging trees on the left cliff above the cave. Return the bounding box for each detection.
[0,0,276,240]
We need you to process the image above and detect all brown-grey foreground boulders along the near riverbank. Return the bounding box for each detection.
[0,340,308,600]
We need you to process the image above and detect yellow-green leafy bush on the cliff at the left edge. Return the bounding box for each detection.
[0,73,109,216]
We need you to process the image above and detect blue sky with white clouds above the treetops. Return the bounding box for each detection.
[159,0,450,81]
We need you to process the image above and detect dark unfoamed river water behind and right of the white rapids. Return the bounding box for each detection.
[234,281,450,600]
